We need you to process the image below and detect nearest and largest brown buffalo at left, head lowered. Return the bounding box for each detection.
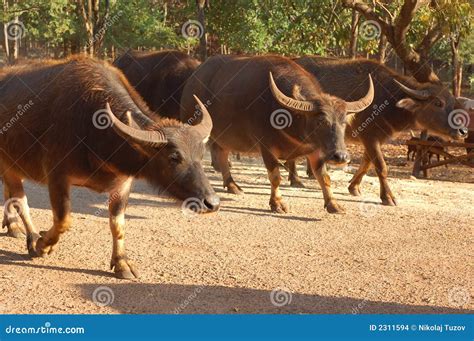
[0,57,219,278]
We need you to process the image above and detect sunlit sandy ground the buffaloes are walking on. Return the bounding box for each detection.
[0,141,474,314]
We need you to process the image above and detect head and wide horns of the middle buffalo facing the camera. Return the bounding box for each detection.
[270,73,374,164]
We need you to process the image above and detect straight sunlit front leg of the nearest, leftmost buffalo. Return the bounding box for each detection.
[109,178,138,279]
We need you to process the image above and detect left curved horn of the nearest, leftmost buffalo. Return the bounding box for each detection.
[105,102,168,147]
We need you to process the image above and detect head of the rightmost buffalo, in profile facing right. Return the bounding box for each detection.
[394,79,468,139]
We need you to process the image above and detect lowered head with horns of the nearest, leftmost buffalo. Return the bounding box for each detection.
[106,96,220,212]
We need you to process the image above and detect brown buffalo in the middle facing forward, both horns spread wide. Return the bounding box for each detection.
[181,56,373,213]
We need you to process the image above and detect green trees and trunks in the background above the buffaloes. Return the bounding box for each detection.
[0,0,474,93]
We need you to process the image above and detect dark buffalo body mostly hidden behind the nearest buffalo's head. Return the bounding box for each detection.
[114,50,200,119]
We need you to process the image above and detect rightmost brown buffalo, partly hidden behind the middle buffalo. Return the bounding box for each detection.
[289,57,467,205]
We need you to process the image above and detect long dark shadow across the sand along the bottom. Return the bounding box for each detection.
[80,282,473,314]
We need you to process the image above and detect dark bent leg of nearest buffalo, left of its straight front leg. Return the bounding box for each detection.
[31,175,71,257]
